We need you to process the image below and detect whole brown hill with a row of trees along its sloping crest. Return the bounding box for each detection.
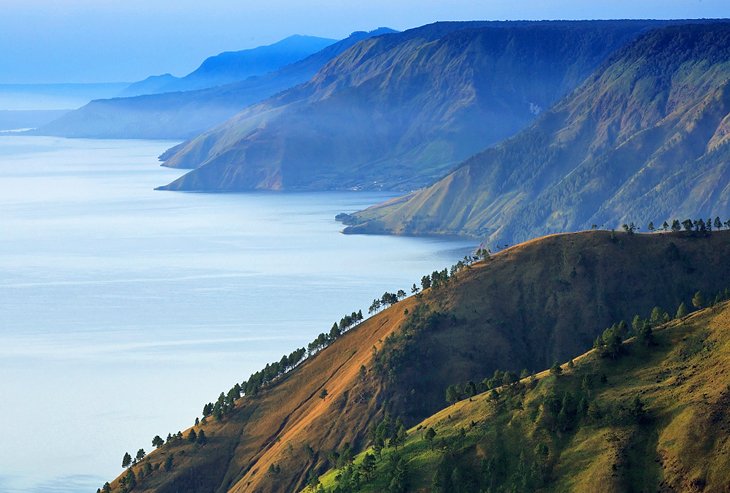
[105,231,730,493]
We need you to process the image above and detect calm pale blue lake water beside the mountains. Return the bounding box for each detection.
[0,136,472,492]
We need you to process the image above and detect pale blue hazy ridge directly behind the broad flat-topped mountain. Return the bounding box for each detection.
[34,28,392,139]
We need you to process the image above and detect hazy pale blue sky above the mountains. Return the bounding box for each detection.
[0,0,730,83]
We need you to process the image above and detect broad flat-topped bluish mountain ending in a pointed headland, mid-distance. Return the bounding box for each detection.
[162,21,663,191]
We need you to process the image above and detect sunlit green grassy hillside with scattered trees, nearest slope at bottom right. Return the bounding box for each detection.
[307,302,730,492]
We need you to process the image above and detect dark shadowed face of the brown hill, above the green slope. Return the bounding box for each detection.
[372,231,730,422]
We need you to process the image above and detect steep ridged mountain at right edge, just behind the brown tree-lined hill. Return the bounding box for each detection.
[343,22,730,244]
